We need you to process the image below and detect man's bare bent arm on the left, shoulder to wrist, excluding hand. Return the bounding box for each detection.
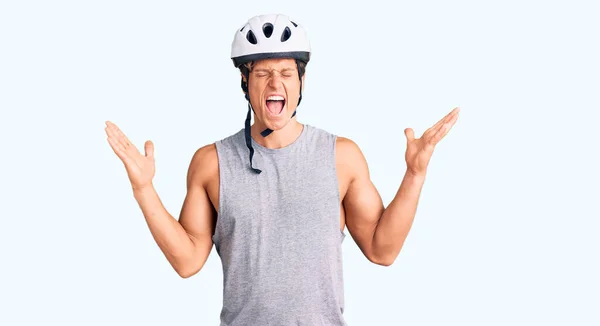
[134,145,218,278]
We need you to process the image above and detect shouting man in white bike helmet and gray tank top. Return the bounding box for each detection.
[106,15,458,326]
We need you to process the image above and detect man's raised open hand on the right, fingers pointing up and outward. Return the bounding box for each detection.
[404,107,460,176]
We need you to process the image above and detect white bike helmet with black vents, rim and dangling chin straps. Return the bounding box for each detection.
[231,14,311,173]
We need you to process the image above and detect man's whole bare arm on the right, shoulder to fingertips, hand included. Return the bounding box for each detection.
[339,109,458,266]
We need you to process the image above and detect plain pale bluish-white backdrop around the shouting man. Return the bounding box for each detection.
[0,0,600,326]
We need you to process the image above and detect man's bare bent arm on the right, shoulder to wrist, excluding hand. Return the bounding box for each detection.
[337,137,424,266]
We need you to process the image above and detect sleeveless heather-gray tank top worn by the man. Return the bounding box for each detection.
[213,124,347,326]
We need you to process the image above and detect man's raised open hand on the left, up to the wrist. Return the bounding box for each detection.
[104,121,155,190]
